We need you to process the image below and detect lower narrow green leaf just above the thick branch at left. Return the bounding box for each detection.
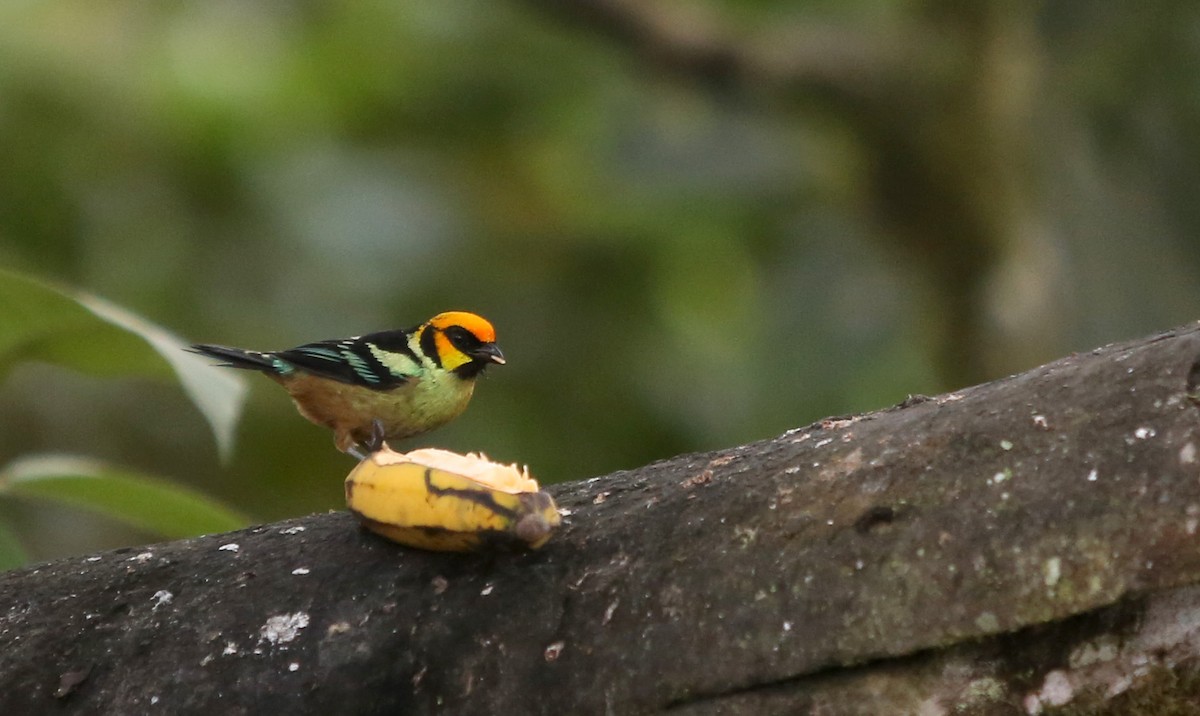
[0,455,250,538]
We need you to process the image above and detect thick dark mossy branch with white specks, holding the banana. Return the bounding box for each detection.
[0,326,1200,714]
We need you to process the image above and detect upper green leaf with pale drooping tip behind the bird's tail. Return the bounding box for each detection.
[0,270,246,458]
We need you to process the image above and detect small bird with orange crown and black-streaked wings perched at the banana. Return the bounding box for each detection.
[190,311,505,459]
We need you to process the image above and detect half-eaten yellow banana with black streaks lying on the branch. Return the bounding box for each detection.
[346,445,562,552]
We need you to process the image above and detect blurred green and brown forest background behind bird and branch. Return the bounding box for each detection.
[0,0,1200,559]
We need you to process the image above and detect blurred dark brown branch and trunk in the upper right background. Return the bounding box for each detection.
[526,0,1033,387]
